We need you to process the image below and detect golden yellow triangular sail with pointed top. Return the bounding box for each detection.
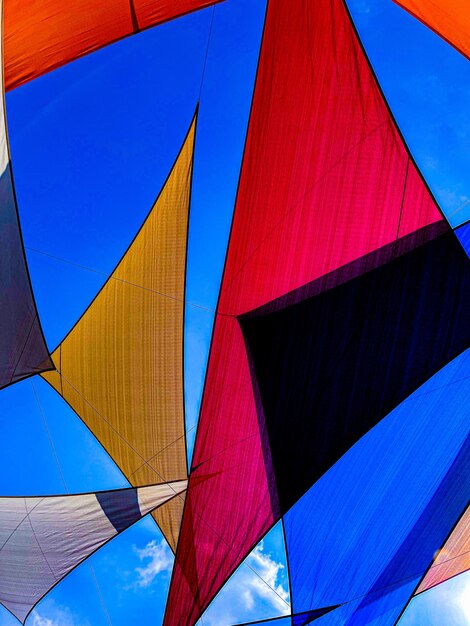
[40,114,195,550]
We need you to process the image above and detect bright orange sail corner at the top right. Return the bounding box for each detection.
[395,0,470,59]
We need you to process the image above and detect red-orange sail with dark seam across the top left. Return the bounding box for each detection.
[4,0,221,91]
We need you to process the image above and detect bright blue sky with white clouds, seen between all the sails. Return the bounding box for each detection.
[0,0,470,626]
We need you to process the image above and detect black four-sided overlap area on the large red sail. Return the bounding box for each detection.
[241,222,470,513]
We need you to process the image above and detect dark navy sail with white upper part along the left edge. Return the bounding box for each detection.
[0,2,52,388]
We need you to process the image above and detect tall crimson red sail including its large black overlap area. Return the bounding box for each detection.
[164,0,470,626]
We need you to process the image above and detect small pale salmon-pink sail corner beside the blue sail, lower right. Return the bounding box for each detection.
[416,508,470,594]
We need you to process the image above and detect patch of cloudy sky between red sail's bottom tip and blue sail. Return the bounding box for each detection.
[200,542,290,626]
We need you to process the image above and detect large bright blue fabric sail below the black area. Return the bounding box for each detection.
[284,350,470,626]
